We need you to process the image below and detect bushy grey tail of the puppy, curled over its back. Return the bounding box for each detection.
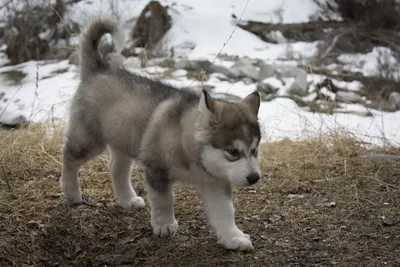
[80,17,125,81]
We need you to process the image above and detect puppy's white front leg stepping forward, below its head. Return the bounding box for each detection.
[200,183,253,251]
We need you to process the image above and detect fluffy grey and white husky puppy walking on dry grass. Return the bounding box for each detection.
[60,18,261,251]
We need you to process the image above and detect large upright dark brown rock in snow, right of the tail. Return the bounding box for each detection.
[132,1,171,50]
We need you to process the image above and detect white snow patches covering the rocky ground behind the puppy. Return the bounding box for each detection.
[0,0,400,146]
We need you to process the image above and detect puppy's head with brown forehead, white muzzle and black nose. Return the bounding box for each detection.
[196,90,261,187]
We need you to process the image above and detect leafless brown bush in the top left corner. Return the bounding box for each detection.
[2,0,76,64]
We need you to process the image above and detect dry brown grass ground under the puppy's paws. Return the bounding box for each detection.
[0,127,400,266]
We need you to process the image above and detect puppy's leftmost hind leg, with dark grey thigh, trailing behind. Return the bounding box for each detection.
[60,130,105,204]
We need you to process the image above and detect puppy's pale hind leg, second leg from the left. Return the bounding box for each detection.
[109,147,145,209]
